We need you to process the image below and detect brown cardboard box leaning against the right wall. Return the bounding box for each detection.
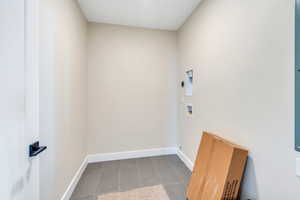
[187,132,248,200]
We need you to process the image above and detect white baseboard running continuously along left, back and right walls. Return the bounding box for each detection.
[61,147,194,200]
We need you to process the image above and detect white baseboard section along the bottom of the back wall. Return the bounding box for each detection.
[87,147,177,163]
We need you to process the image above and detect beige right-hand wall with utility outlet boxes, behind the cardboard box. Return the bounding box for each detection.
[178,0,300,200]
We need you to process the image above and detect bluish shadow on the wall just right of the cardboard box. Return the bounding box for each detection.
[241,156,259,200]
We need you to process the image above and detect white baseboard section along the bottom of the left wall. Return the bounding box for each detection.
[61,158,88,200]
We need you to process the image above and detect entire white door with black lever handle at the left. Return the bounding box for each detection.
[0,0,39,200]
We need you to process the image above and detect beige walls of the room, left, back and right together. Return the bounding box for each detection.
[40,0,300,200]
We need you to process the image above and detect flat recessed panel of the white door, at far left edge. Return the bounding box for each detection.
[0,0,26,200]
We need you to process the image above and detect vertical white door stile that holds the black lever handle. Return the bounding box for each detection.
[24,0,40,200]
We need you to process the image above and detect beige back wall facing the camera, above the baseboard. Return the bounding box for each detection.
[88,23,177,154]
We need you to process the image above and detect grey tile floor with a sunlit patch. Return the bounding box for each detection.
[71,155,191,200]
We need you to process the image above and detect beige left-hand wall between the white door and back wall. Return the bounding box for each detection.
[40,0,87,200]
